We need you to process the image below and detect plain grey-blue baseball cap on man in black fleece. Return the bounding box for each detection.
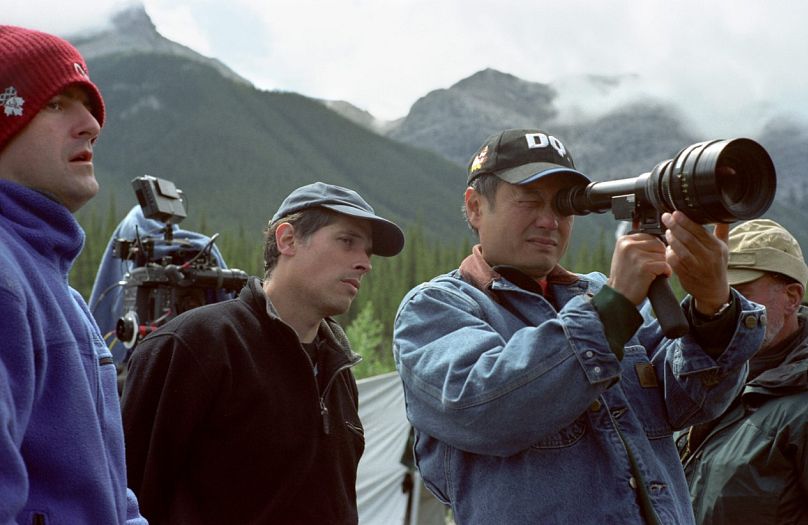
[270,182,404,257]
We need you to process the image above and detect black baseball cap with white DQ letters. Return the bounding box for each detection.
[467,129,590,184]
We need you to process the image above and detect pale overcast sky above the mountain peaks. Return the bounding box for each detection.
[6,0,808,138]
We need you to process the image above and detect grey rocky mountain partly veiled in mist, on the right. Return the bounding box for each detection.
[328,69,808,230]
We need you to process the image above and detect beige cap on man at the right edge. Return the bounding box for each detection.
[727,219,808,286]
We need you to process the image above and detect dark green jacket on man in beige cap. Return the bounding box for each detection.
[683,308,808,525]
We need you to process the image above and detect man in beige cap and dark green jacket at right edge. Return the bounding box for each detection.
[683,219,808,524]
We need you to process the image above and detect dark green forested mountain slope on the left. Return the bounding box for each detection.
[84,54,466,244]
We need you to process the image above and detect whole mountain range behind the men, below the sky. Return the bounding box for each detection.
[71,7,808,252]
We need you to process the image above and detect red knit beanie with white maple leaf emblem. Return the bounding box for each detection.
[0,25,104,151]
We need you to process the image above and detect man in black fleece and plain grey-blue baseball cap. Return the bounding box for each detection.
[123,182,404,524]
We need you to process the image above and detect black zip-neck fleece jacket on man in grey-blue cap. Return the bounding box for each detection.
[123,278,364,524]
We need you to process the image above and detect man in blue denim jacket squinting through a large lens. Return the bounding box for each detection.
[394,129,764,524]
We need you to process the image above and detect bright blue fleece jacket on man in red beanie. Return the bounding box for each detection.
[0,180,145,525]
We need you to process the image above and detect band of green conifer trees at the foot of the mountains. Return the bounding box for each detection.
[70,203,613,377]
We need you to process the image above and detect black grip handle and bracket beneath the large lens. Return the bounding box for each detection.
[611,194,690,339]
